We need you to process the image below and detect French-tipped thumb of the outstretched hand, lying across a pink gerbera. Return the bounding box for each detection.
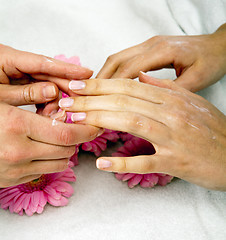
[96,154,172,174]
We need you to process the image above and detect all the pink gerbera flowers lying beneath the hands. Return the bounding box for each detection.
[0,55,173,216]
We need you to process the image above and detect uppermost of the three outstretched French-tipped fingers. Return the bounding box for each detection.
[67,78,168,103]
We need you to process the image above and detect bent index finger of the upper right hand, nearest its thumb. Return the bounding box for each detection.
[111,47,173,78]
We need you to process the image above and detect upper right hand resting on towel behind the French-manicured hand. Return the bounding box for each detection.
[97,24,226,92]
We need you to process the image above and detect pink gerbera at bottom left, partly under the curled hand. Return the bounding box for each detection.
[0,165,76,216]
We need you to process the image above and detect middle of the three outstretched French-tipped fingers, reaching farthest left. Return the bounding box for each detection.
[59,94,166,123]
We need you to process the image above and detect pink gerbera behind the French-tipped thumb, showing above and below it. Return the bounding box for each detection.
[112,134,173,188]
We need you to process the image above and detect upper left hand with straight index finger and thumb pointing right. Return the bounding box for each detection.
[0,44,92,115]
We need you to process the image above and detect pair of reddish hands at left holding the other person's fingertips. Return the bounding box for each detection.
[0,45,102,188]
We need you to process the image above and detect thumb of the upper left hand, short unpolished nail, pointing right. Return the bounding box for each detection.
[0,82,59,106]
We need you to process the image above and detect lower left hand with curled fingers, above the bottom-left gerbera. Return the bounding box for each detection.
[0,103,101,188]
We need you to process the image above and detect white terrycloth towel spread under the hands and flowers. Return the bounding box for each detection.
[0,0,226,240]
